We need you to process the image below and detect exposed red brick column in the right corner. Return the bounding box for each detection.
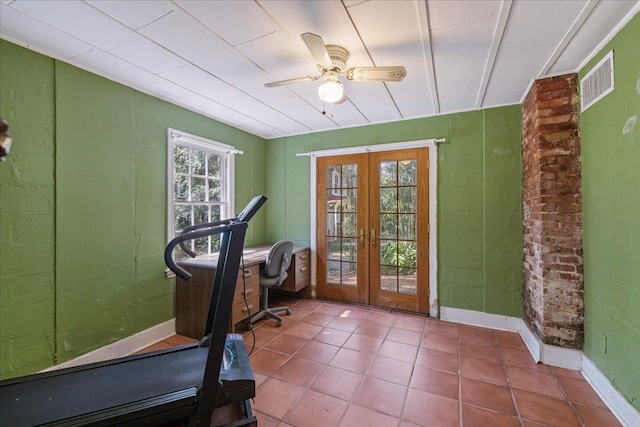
[522,74,584,349]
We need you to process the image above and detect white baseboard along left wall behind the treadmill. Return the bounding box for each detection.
[42,319,176,372]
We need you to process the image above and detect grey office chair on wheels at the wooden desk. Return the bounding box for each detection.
[249,240,293,329]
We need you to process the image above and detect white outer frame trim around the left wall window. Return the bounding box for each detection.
[167,128,242,254]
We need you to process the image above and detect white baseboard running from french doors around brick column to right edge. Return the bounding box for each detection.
[440,307,640,427]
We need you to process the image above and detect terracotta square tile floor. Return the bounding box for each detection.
[153,299,620,427]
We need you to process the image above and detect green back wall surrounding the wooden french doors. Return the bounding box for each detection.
[267,106,522,317]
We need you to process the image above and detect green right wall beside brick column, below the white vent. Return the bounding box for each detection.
[580,15,640,409]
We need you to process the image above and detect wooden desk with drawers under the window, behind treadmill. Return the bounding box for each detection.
[176,245,311,340]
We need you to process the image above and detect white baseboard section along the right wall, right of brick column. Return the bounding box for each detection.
[582,355,640,427]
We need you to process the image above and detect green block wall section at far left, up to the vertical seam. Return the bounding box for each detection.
[0,41,56,377]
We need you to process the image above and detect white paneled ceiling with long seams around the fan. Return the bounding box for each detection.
[0,0,640,139]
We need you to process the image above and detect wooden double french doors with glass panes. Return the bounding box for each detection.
[316,148,429,313]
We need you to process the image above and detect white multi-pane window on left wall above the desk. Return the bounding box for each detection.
[167,129,241,257]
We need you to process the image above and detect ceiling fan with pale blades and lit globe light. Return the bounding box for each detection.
[265,33,407,104]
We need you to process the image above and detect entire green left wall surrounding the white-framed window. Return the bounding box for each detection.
[0,41,266,378]
